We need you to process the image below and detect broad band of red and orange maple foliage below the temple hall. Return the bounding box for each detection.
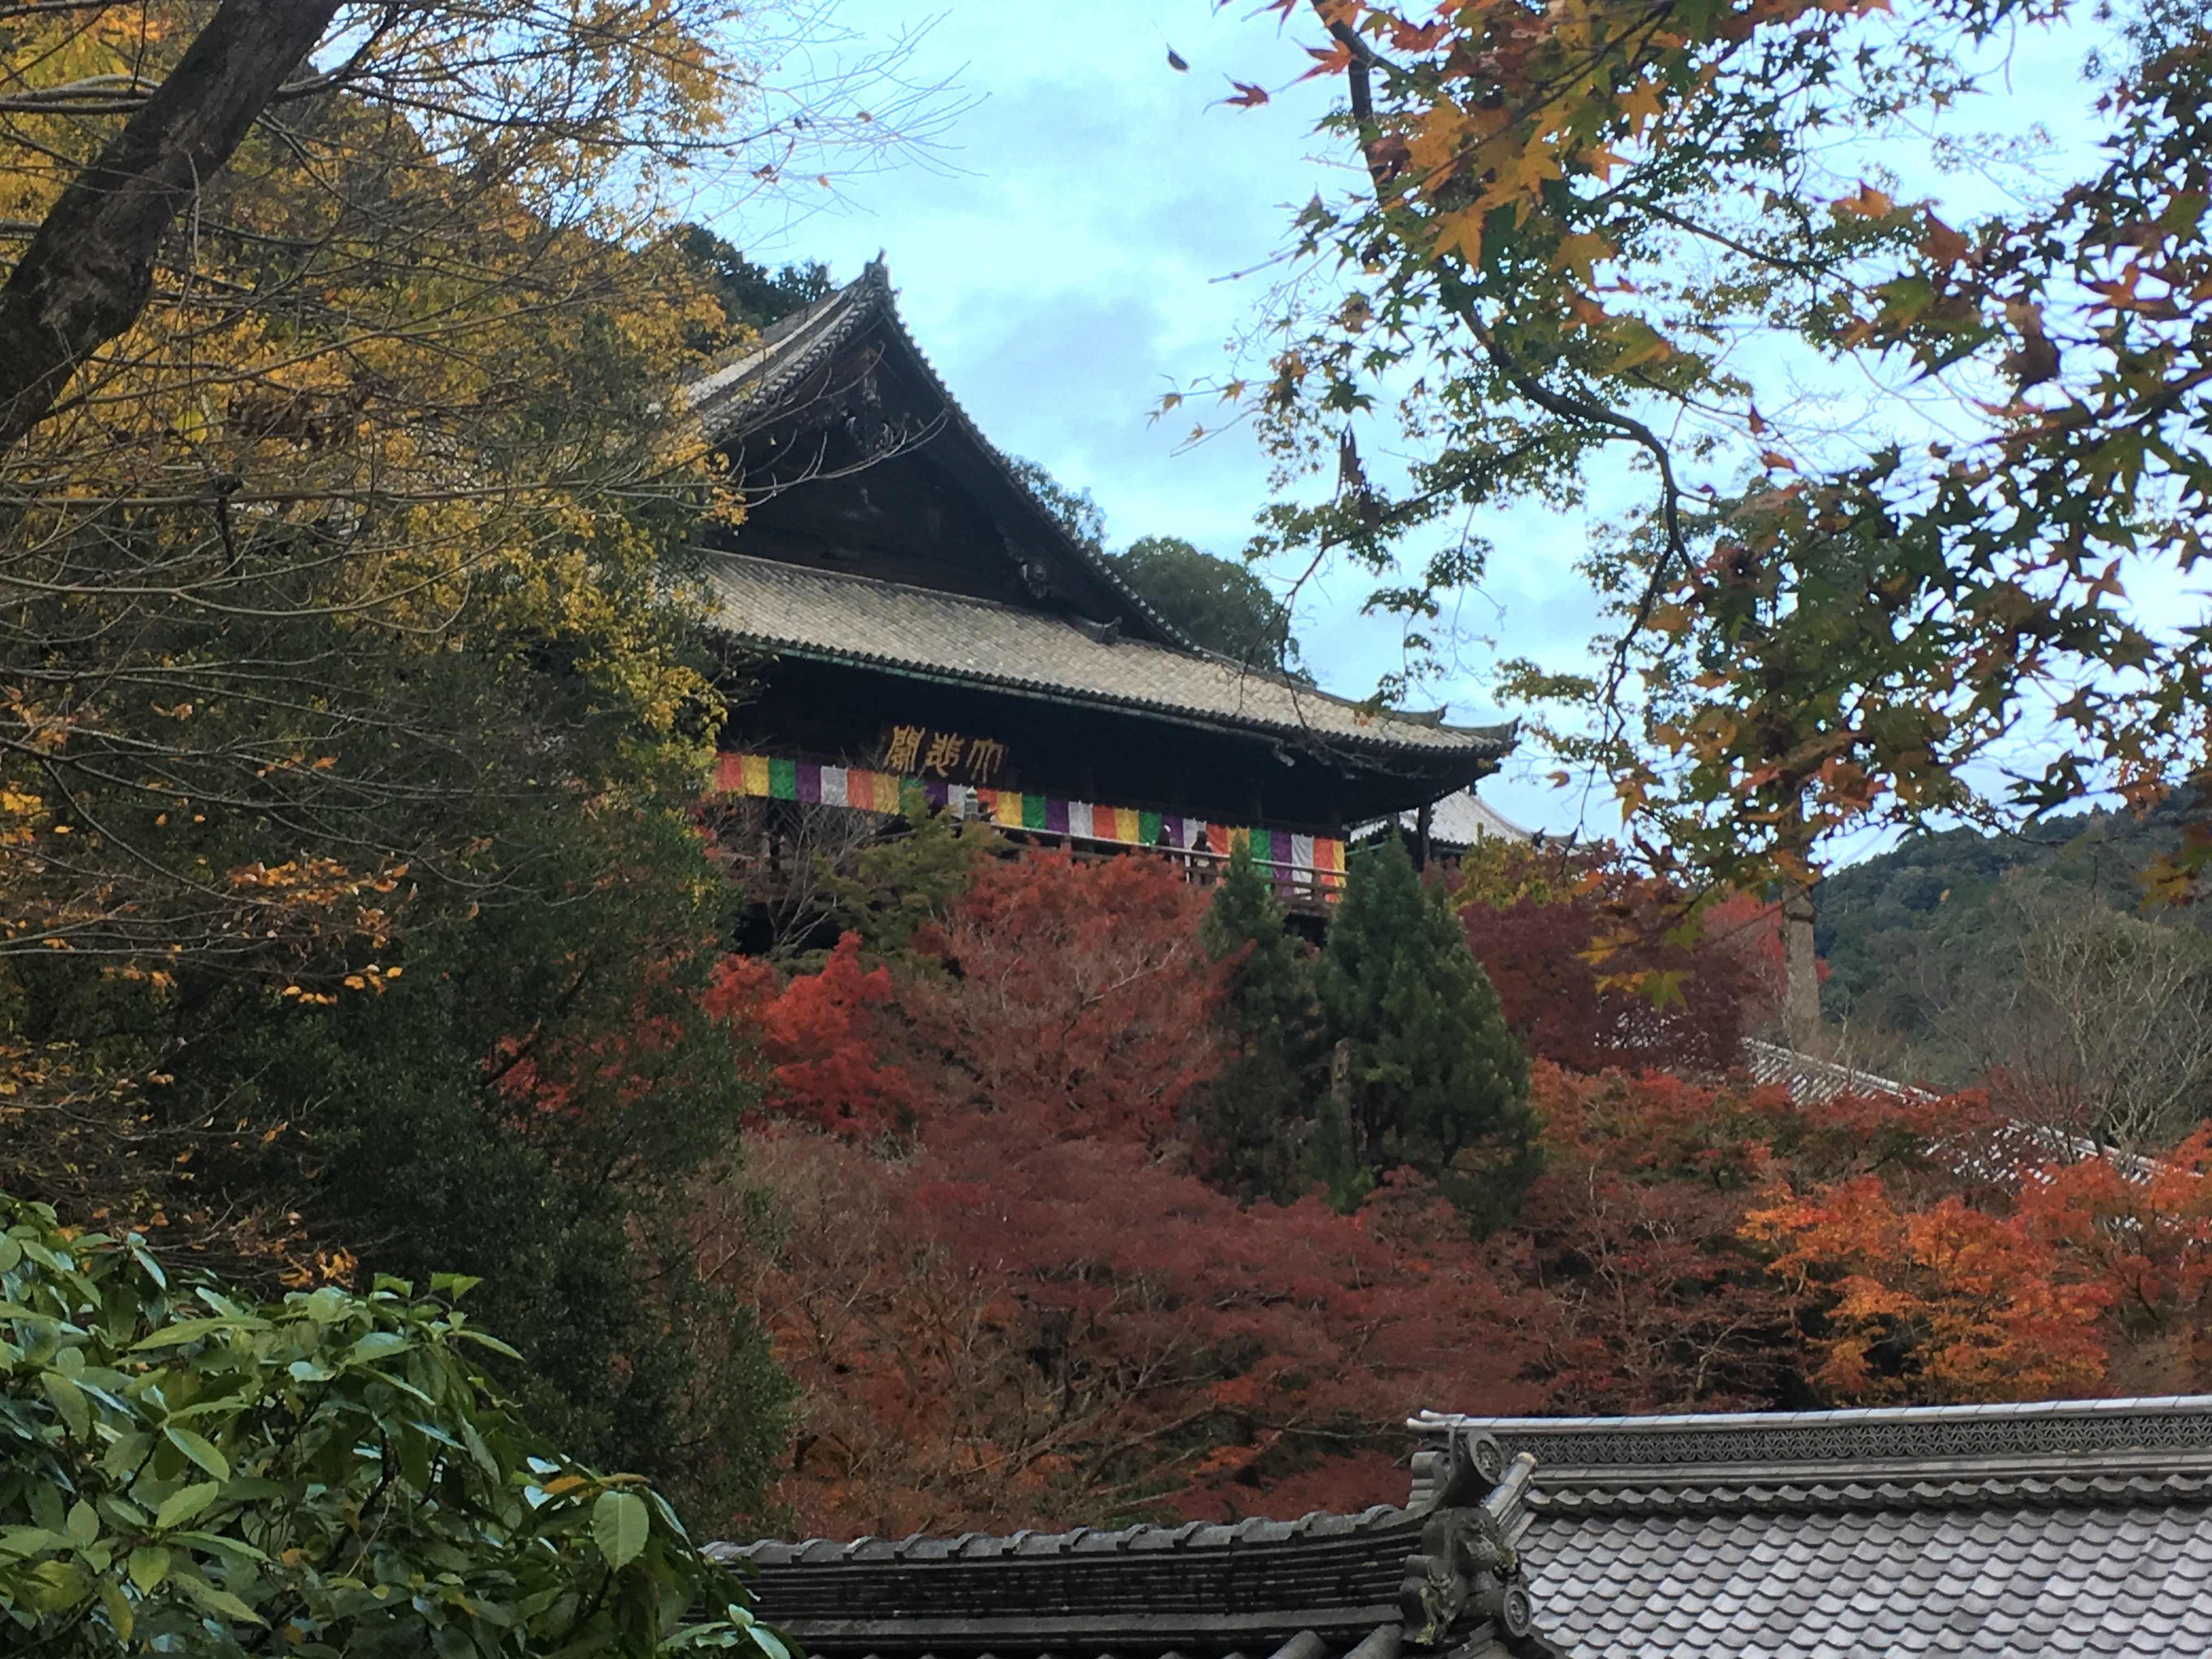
[692,854,2212,1535]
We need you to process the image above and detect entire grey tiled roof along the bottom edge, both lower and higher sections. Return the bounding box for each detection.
[716,1396,2212,1659]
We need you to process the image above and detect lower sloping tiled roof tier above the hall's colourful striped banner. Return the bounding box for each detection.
[708,553,1513,759]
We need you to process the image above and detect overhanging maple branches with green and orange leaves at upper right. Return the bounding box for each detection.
[1217,0,2212,889]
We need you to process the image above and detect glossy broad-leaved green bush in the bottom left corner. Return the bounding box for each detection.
[0,1199,789,1659]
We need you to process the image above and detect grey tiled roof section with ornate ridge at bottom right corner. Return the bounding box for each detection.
[1415,1398,2212,1659]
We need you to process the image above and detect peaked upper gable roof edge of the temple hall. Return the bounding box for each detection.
[686,255,1190,648]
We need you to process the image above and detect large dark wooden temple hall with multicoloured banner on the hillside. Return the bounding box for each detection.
[692,261,1513,900]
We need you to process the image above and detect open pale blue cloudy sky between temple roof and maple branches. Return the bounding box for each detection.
[708,0,2123,834]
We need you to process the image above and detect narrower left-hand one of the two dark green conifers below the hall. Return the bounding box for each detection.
[1194,847,1327,1203]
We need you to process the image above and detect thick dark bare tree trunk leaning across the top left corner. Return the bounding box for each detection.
[0,0,338,449]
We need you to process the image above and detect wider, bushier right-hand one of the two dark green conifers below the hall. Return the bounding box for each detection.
[1318,836,1537,1228]
